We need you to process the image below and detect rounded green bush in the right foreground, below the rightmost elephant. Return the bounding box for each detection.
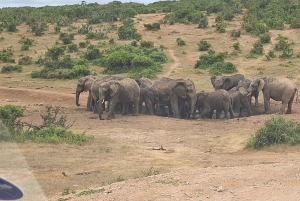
[246,116,300,149]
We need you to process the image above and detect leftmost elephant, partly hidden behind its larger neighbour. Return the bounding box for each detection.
[76,75,97,111]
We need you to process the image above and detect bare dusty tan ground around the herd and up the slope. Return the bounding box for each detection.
[0,12,300,201]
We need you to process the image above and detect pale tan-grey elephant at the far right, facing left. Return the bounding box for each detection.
[247,77,298,114]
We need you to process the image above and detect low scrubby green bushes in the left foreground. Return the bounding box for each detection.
[0,105,90,145]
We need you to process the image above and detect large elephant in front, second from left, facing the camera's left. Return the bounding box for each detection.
[98,78,140,120]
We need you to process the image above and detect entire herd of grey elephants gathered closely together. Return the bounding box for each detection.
[76,74,298,120]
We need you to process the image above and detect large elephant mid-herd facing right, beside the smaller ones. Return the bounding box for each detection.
[151,77,197,118]
